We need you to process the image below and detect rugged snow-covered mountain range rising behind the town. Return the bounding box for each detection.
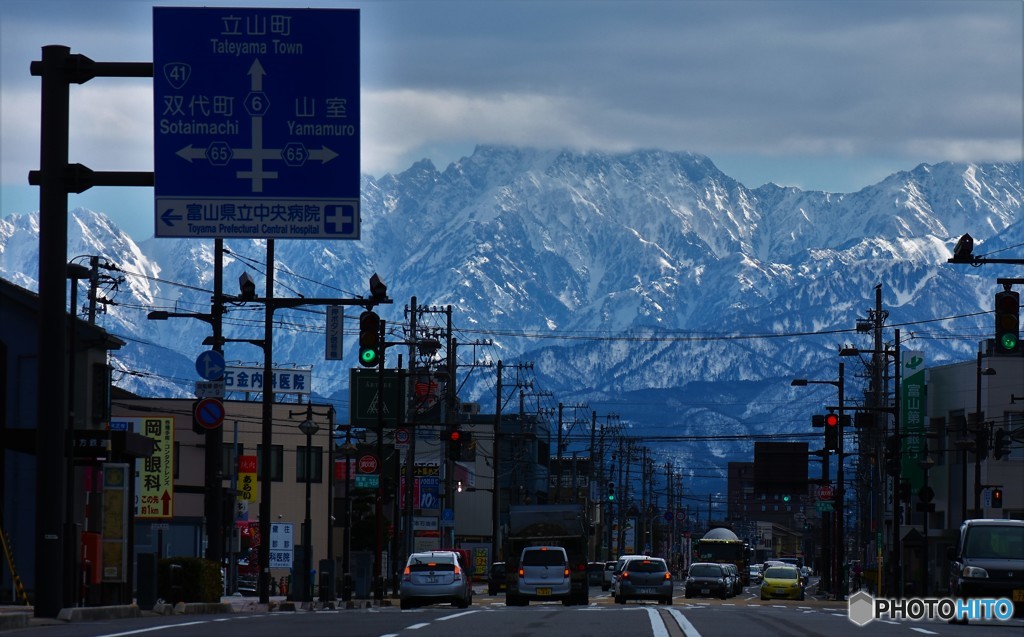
[0,146,1024,489]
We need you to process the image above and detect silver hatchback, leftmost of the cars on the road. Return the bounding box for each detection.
[399,551,473,609]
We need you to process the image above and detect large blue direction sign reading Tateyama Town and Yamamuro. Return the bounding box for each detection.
[153,7,359,239]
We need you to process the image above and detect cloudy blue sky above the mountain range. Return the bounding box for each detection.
[0,0,1024,240]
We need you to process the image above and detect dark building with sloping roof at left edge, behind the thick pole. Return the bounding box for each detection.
[0,279,130,604]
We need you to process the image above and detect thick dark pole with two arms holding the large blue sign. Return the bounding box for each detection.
[29,45,153,618]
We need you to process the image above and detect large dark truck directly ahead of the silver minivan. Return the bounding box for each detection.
[503,504,590,606]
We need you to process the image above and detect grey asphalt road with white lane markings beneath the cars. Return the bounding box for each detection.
[3,587,1024,637]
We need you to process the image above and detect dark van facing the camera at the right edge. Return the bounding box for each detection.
[948,519,1024,617]
